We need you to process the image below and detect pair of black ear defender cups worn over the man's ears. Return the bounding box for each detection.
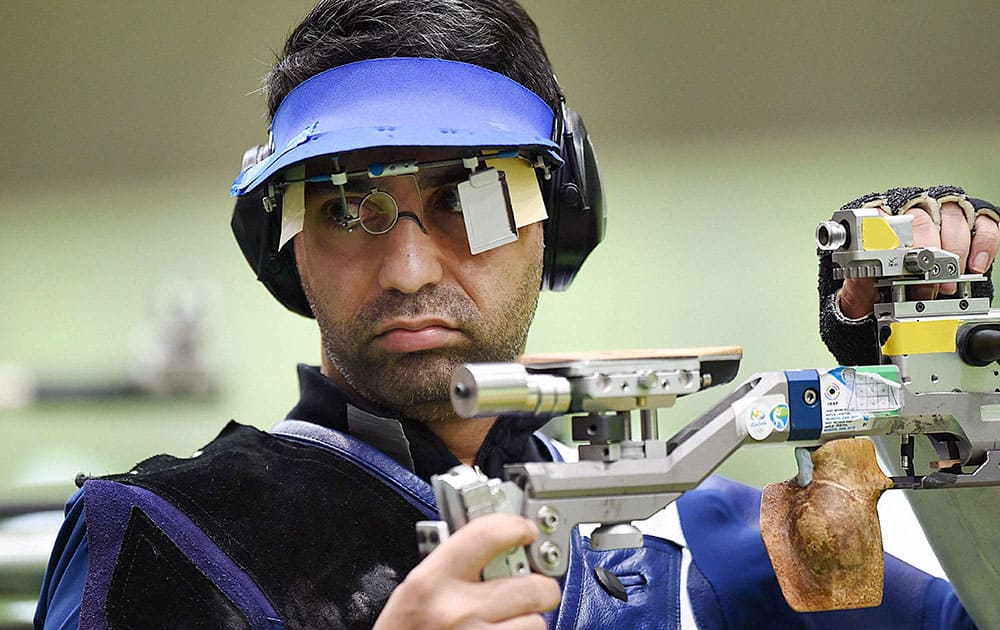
[231,80,606,317]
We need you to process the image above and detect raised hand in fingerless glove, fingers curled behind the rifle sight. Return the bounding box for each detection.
[837,186,1000,319]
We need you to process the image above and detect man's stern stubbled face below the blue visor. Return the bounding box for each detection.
[295,150,543,422]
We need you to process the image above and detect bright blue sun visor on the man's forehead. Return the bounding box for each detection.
[230,57,563,196]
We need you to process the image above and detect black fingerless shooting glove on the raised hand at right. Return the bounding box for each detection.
[819,186,1000,365]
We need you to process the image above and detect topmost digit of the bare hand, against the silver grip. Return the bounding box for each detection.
[414,514,538,582]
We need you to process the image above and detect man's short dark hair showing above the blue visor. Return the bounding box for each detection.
[264,0,559,118]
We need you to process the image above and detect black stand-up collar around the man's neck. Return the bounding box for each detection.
[287,364,560,480]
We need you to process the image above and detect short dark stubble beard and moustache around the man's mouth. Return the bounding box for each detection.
[303,262,541,424]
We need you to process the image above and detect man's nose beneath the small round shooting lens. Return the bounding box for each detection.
[377,183,444,293]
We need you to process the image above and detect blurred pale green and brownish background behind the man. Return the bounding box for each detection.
[0,6,1000,624]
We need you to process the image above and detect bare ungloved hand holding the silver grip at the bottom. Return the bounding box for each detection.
[375,514,561,630]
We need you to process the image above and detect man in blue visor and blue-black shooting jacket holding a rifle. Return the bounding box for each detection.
[36,0,996,628]
